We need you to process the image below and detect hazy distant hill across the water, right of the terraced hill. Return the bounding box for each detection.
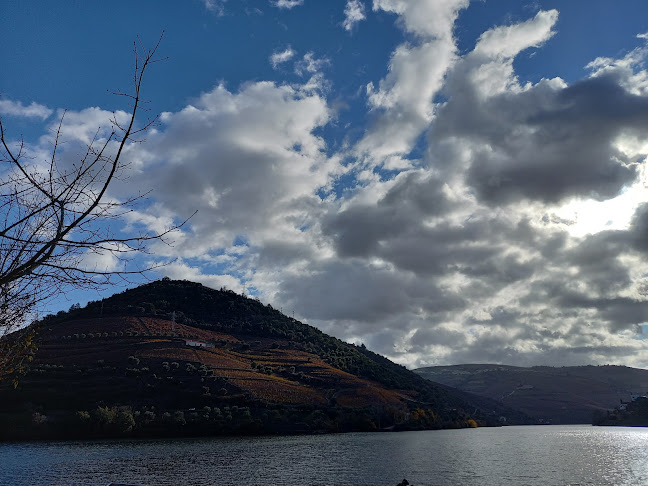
[414,364,648,424]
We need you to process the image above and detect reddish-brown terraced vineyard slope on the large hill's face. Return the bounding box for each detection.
[20,316,404,409]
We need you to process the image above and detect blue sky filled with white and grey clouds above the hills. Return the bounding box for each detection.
[0,0,648,367]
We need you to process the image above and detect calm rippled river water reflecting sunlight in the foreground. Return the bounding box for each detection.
[0,426,648,486]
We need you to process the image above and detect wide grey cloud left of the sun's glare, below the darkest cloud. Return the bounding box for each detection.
[323,183,540,287]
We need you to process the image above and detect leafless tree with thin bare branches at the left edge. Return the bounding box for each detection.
[0,37,184,374]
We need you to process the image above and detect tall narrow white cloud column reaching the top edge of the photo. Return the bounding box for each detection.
[355,0,468,167]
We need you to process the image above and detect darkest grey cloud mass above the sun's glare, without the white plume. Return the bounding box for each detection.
[432,69,648,204]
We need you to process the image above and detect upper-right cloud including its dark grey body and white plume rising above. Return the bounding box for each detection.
[431,11,648,204]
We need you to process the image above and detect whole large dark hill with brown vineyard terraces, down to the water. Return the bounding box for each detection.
[0,279,530,440]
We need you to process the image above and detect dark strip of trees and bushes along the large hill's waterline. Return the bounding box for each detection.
[0,406,477,442]
